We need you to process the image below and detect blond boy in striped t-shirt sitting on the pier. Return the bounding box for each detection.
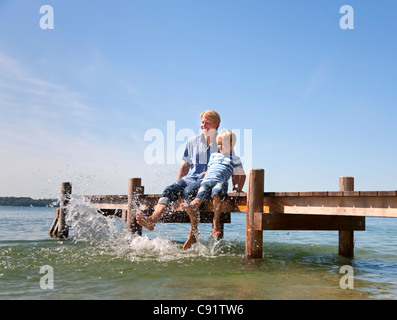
[181,130,246,250]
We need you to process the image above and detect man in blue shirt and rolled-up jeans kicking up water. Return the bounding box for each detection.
[136,110,221,247]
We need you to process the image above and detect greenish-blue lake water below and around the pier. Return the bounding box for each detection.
[0,198,397,300]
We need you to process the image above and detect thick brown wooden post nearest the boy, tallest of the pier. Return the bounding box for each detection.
[245,169,265,259]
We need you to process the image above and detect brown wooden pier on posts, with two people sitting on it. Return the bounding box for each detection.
[50,169,397,259]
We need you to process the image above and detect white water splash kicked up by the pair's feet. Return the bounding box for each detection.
[66,195,241,261]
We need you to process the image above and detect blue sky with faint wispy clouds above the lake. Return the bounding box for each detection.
[0,0,397,198]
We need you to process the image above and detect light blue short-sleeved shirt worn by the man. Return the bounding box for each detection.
[182,134,218,185]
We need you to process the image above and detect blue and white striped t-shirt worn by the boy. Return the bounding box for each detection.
[203,153,243,183]
